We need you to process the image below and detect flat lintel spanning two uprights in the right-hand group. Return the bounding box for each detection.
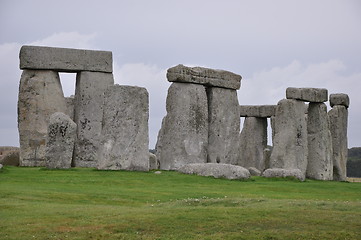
[286,88,328,103]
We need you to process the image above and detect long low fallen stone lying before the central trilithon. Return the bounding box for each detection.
[177,163,251,179]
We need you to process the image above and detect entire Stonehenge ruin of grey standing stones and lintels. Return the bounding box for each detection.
[18,46,350,181]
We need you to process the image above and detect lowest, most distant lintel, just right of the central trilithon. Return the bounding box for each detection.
[239,105,277,118]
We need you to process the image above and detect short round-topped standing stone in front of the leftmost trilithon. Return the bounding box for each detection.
[45,112,76,168]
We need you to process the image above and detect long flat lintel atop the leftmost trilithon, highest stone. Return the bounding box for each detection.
[20,46,113,73]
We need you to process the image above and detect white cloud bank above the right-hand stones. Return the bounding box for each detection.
[238,60,361,146]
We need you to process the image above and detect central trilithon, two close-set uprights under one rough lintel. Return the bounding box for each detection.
[156,65,241,170]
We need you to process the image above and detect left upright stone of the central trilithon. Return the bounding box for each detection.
[156,83,208,170]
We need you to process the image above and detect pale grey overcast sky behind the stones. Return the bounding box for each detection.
[0,0,361,148]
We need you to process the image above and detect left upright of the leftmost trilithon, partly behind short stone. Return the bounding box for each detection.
[18,70,66,166]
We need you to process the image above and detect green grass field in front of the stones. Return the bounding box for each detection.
[0,167,361,240]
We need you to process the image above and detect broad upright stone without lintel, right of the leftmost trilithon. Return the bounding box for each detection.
[97,85,149,171]
